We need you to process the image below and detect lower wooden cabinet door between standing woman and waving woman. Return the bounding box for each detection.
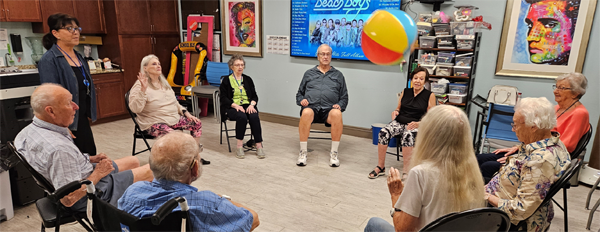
[95,81,126,119]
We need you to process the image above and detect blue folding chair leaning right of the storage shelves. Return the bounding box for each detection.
[479,103,519,153]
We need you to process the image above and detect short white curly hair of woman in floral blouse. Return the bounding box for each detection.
[515,97,556,130]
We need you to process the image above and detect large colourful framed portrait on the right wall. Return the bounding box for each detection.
[496,0,597,78]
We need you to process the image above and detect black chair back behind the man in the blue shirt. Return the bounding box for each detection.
[87,183,193,232]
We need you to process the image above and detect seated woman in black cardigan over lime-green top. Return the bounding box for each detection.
[219,54,265,159]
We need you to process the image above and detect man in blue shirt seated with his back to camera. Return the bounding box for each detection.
[119,131,259,231]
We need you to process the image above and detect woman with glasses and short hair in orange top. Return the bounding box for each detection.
[477,73,590,179]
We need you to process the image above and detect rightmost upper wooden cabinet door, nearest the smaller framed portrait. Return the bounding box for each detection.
[148,0,179,34]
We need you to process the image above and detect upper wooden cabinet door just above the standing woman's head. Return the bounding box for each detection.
[31,0,73,33]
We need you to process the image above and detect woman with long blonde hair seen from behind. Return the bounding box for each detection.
[365,105,485,232]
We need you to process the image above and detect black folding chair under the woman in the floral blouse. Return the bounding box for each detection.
[516,159,582,232]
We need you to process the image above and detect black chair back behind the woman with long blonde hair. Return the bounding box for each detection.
[419,208,510,232]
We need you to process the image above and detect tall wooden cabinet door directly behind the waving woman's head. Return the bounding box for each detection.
[119,35,152,90]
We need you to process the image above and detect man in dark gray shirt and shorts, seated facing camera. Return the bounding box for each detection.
[296,44,348,167]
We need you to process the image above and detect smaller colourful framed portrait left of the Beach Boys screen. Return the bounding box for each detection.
[221,0,263,57]
